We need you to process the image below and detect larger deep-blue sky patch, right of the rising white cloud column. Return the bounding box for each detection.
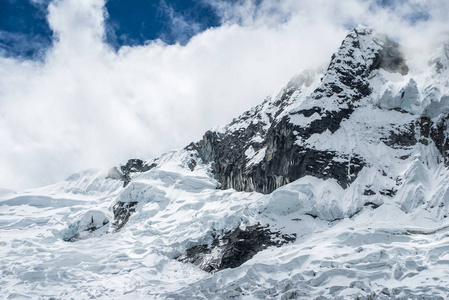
[106,0,221,47]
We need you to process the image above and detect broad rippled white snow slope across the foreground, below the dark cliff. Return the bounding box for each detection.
[0,156,449,299]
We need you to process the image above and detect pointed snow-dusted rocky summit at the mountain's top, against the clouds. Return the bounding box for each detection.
[304,26,408,110]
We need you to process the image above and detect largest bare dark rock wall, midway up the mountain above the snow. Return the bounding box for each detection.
[198,112,365,193]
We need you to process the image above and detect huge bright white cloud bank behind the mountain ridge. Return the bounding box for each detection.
[0,0,449,188]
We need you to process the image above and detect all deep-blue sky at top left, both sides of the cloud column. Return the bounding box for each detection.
[0,0,232,58]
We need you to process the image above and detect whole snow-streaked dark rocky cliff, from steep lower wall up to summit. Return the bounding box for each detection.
[193,27,416,193]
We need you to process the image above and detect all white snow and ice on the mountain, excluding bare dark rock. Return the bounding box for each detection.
[0,28,449,299]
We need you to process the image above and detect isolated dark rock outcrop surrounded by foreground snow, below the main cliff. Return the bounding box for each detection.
[178,225,296,273]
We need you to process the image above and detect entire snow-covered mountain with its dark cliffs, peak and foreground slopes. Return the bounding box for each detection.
[0,27,449,299]
